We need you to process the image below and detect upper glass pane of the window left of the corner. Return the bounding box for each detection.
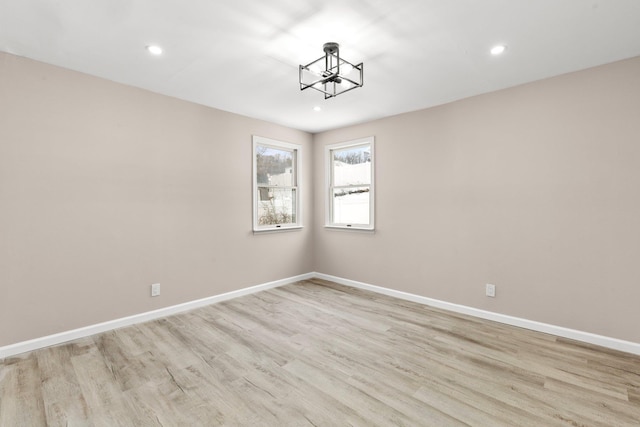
[256,145,296,187]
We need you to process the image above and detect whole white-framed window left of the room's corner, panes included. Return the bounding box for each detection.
[253,136,302,231]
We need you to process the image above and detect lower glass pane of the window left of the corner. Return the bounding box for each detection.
[257,187,296,225]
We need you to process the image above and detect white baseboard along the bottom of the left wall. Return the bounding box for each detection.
[0,273,314,359]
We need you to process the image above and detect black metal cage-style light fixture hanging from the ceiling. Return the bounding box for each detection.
[300,42,363,99]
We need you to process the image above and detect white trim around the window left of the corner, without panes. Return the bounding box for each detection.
[251,135,302,233]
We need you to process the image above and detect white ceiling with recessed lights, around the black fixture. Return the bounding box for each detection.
[0,0,640,132]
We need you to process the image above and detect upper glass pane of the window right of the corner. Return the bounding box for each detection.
[331,144,371,186]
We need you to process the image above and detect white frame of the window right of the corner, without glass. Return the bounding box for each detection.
[324,136,375,231]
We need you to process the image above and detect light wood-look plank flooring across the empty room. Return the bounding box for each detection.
[0,280,640,427]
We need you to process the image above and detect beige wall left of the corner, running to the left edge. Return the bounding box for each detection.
[0,53,313,346]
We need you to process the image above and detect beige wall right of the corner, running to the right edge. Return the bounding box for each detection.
[314,58,640,342]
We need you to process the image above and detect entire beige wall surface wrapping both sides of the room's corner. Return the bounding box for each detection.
[0,53,640,346]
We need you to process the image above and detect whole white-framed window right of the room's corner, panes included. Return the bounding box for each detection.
[325,137,374,230]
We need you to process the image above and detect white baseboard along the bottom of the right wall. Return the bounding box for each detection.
[312,273,640,355]
